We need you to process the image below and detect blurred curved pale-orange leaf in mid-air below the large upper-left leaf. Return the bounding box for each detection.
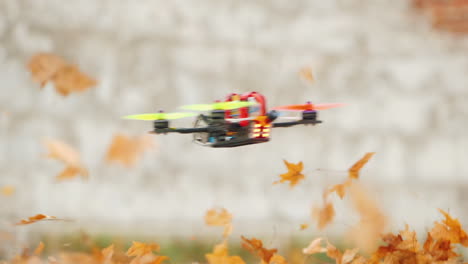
[44,139,88,181]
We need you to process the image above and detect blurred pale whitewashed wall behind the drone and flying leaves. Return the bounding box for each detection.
[0,0,468,260]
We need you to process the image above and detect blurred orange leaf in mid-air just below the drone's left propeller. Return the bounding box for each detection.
[107,134,154,167]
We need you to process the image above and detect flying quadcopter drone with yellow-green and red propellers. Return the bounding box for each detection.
[124,92,342,148]
